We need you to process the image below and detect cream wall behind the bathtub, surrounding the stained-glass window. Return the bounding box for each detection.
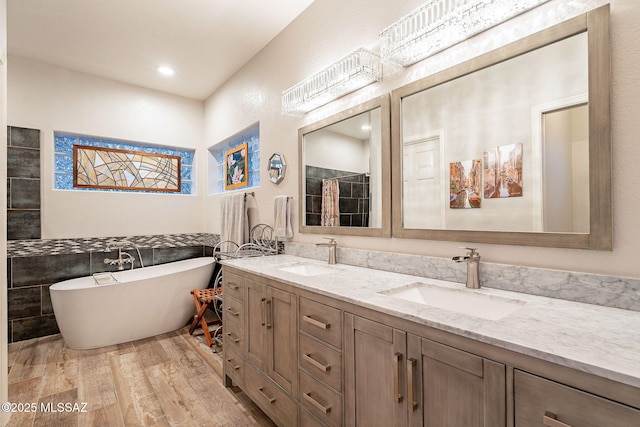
[8,56,207,239]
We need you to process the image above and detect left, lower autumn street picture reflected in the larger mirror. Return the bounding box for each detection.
[449,159,482,209]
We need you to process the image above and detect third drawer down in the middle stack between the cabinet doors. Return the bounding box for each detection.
[299,371,342,426]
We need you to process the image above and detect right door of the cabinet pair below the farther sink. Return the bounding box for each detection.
[266,287,298,396]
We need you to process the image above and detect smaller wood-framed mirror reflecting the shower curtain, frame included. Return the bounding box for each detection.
[298,95,391,237]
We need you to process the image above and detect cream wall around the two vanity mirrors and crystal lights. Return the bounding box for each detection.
[205,0,640,276]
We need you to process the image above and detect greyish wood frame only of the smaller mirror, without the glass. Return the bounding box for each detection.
[298,94,391,237]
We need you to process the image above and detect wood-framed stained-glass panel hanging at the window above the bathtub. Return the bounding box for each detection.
[73,145,181,193]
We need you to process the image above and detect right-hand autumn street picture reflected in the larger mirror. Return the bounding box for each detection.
[483,144,522,199]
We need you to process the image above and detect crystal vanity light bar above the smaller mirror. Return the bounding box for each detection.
[282,48,382,115]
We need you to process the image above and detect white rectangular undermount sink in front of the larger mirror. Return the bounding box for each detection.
[379,283,527,320]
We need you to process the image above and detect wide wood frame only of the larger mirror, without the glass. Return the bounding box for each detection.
[391,5,612,250]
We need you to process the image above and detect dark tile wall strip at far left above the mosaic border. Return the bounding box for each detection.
[7,126,40,240]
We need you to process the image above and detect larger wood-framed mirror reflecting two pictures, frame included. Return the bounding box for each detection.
[391,5,612,250]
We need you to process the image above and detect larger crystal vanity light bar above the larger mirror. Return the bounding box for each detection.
[380,0,549,67]
